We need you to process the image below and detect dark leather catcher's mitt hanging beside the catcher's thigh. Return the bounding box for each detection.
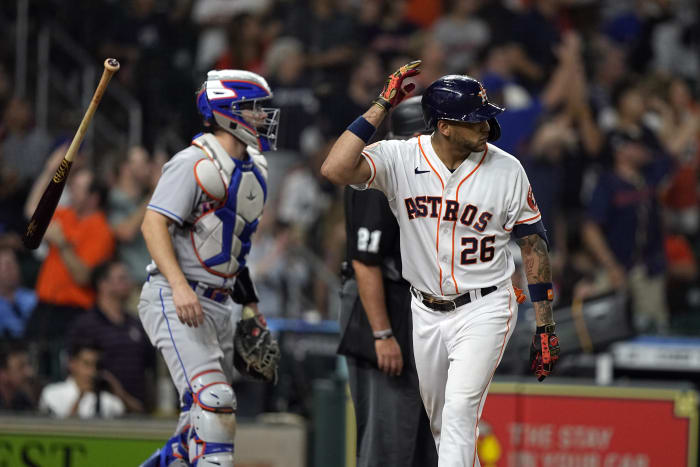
[233,307,280,383]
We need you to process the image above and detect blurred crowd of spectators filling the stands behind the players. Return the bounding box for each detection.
[0,0,700,417]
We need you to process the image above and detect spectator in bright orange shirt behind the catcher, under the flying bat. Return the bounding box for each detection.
[27,169,115,376]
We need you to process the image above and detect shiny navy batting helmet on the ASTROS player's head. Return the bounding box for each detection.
[421,75,505,141]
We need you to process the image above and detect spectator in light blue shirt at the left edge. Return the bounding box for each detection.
[0,247,37,339]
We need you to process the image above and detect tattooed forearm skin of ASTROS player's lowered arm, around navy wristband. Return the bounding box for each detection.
[515,234,554,326]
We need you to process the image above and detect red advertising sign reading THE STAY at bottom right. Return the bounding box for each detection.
[478,384,697,467]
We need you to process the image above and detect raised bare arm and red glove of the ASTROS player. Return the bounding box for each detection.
[321,60,421,185]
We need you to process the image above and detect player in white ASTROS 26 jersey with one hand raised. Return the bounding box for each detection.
[321,61,559,467]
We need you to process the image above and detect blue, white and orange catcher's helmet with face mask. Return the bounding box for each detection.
[197,70,280,151]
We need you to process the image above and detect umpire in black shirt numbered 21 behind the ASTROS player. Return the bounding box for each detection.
[338,96,437,467]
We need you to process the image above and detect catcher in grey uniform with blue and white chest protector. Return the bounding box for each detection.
[139,70,279,467]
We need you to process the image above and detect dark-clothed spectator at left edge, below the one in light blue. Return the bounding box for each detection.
[0,341,36,411]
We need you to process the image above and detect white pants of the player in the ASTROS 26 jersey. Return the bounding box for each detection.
[411,280,518,467]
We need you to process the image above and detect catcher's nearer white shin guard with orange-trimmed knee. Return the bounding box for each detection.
[189,370,236,467]
